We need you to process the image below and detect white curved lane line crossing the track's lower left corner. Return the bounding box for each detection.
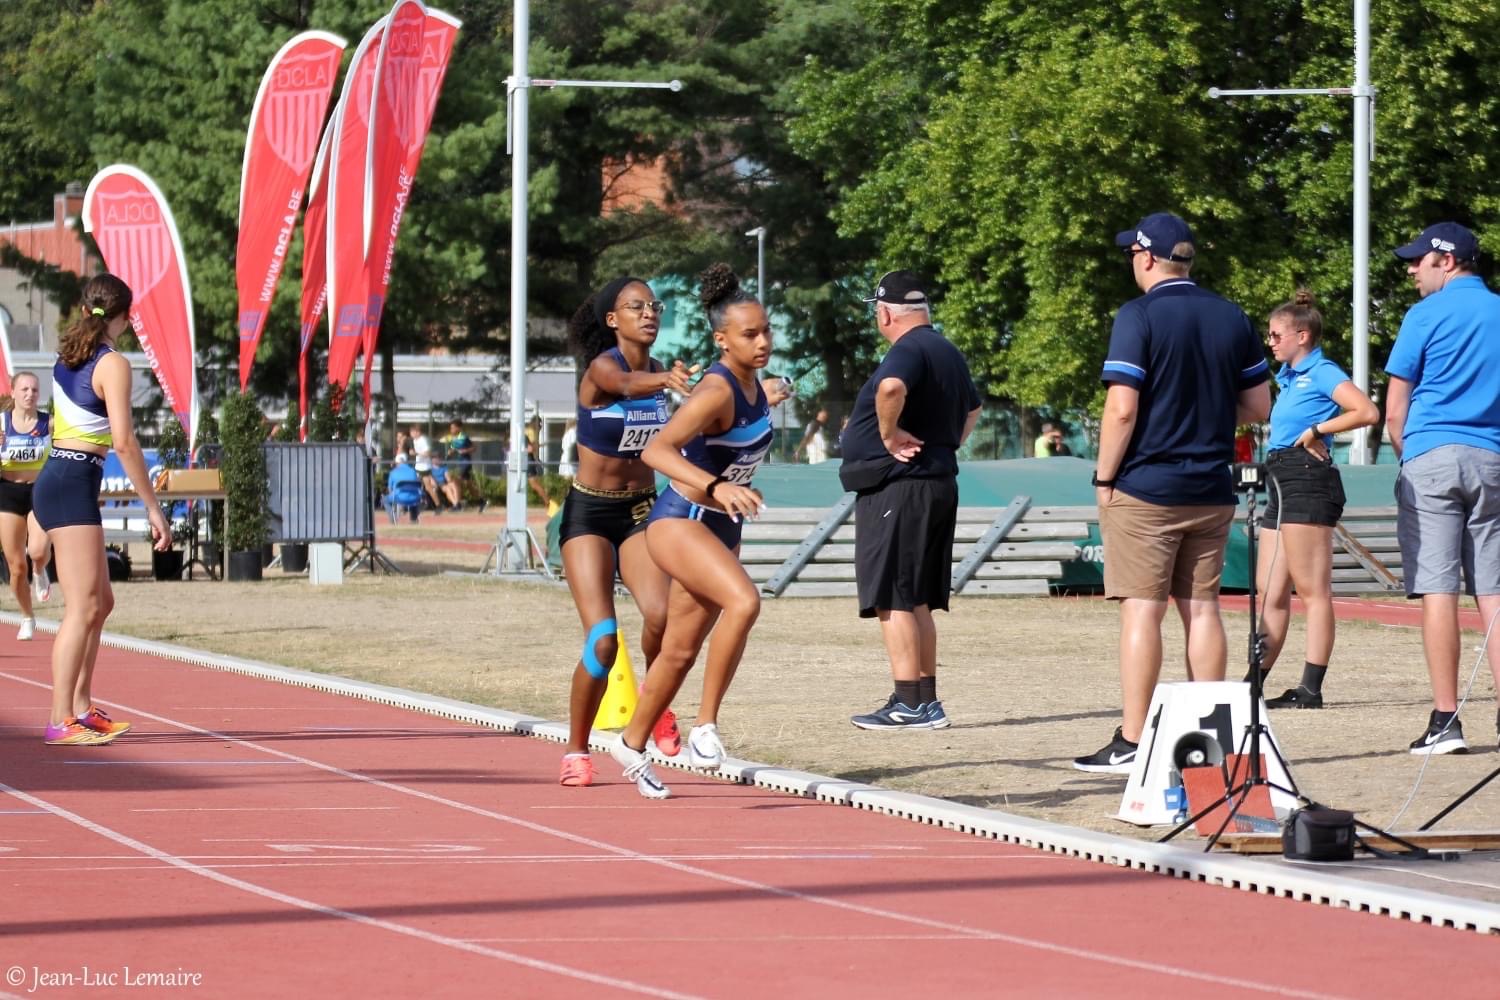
[0,781,696,1000]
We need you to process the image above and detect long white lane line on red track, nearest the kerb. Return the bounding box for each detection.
[0,672,1337,1000]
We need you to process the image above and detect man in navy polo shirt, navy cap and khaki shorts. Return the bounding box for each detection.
[1073,211,1271,774]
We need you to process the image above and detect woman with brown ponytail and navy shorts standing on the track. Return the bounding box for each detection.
[32,274,173,745]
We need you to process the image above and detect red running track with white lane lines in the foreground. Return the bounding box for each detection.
[0,640,1500,999]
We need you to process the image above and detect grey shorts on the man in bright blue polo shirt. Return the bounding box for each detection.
[1397,444,1500,597]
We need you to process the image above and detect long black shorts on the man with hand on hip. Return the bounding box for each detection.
[854,477,959,618]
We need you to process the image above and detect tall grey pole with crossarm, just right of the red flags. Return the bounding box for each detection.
[485,0,683,574]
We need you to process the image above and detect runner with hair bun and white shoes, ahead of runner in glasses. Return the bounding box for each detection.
[611,264,789,799]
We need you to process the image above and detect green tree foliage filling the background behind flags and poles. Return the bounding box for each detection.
[0,0,1500,434]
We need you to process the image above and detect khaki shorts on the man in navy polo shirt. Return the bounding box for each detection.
[1100,490,1235,601]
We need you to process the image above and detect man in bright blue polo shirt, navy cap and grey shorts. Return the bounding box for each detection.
[1386,222,1500,754]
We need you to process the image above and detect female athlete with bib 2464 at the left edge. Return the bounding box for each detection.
[0,372,51,642]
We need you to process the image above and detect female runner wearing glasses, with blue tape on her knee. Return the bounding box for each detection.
[558,277,696,787]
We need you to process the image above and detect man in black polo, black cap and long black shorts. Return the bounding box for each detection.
[839,271,980,729]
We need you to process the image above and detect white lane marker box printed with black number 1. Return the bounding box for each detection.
[1115,681,1296,826]
